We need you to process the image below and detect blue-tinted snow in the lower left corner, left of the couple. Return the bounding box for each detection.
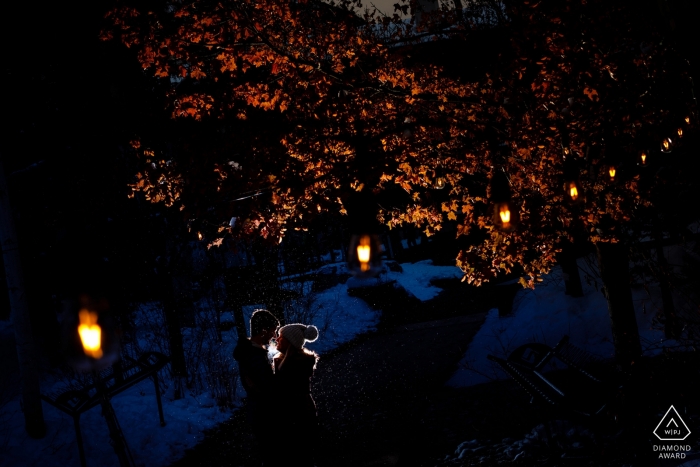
[0,304,235,467]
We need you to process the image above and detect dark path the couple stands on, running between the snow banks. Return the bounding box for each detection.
[172,313,486,467]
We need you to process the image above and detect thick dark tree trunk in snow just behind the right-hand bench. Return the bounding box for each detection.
[596,242,642,367]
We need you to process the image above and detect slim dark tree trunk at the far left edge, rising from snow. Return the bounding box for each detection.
[0,160,46,438]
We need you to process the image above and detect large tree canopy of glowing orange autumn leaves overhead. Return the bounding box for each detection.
[103,0,697,364]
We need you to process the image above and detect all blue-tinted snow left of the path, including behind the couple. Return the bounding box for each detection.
[0,261,461,467]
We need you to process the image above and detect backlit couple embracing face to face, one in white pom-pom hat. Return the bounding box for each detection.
[233,310,318,466]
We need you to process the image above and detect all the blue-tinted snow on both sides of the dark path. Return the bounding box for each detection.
[0,261,680,467]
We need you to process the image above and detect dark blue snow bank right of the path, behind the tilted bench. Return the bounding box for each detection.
[447,259,676,387]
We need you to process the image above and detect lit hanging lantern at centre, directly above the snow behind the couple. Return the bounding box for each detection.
[346,192,383,278]
